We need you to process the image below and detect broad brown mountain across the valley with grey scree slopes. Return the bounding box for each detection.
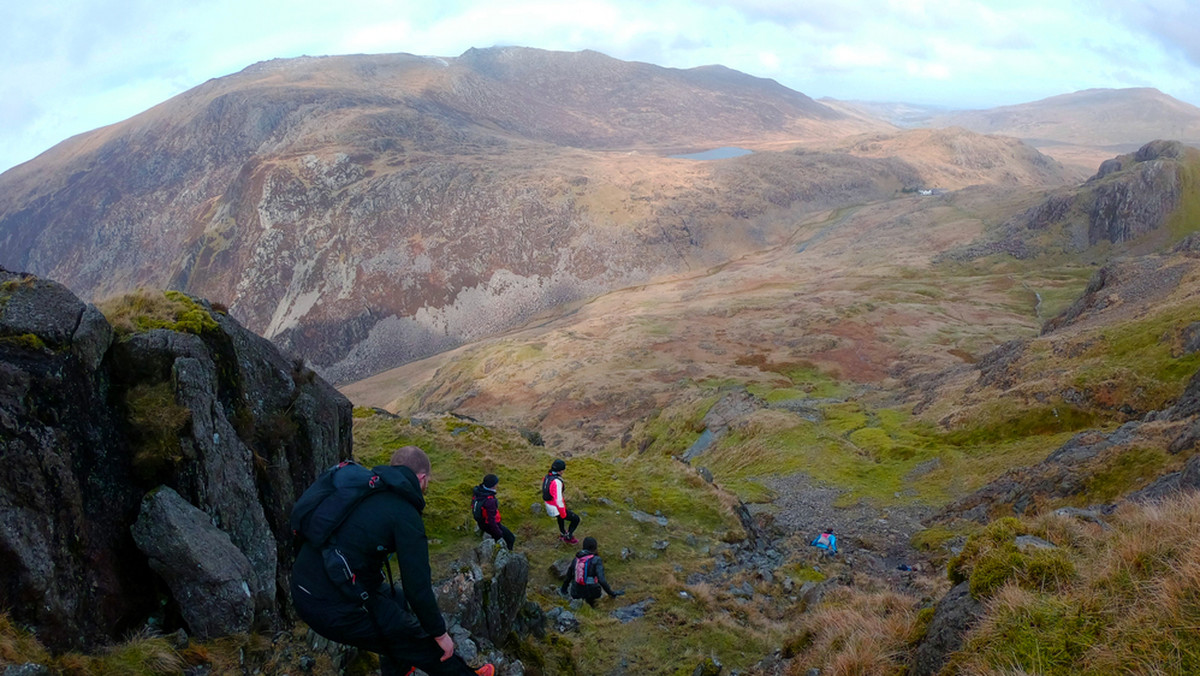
[0,48,1064,382]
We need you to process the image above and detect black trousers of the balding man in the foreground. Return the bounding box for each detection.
[292,575,475,676]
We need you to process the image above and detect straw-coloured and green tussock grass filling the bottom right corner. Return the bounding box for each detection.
[952,493,1200,676]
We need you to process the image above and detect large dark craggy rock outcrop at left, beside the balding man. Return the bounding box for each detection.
[0,270,352,650]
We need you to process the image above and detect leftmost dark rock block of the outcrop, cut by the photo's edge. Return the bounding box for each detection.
[0,270,156,650]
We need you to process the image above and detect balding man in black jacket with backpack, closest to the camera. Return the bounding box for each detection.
[292,445,494,676]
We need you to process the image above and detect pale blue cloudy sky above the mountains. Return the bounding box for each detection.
[0,0,1200,172]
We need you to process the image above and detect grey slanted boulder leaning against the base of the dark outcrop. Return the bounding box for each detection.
[133,486,254,641]
